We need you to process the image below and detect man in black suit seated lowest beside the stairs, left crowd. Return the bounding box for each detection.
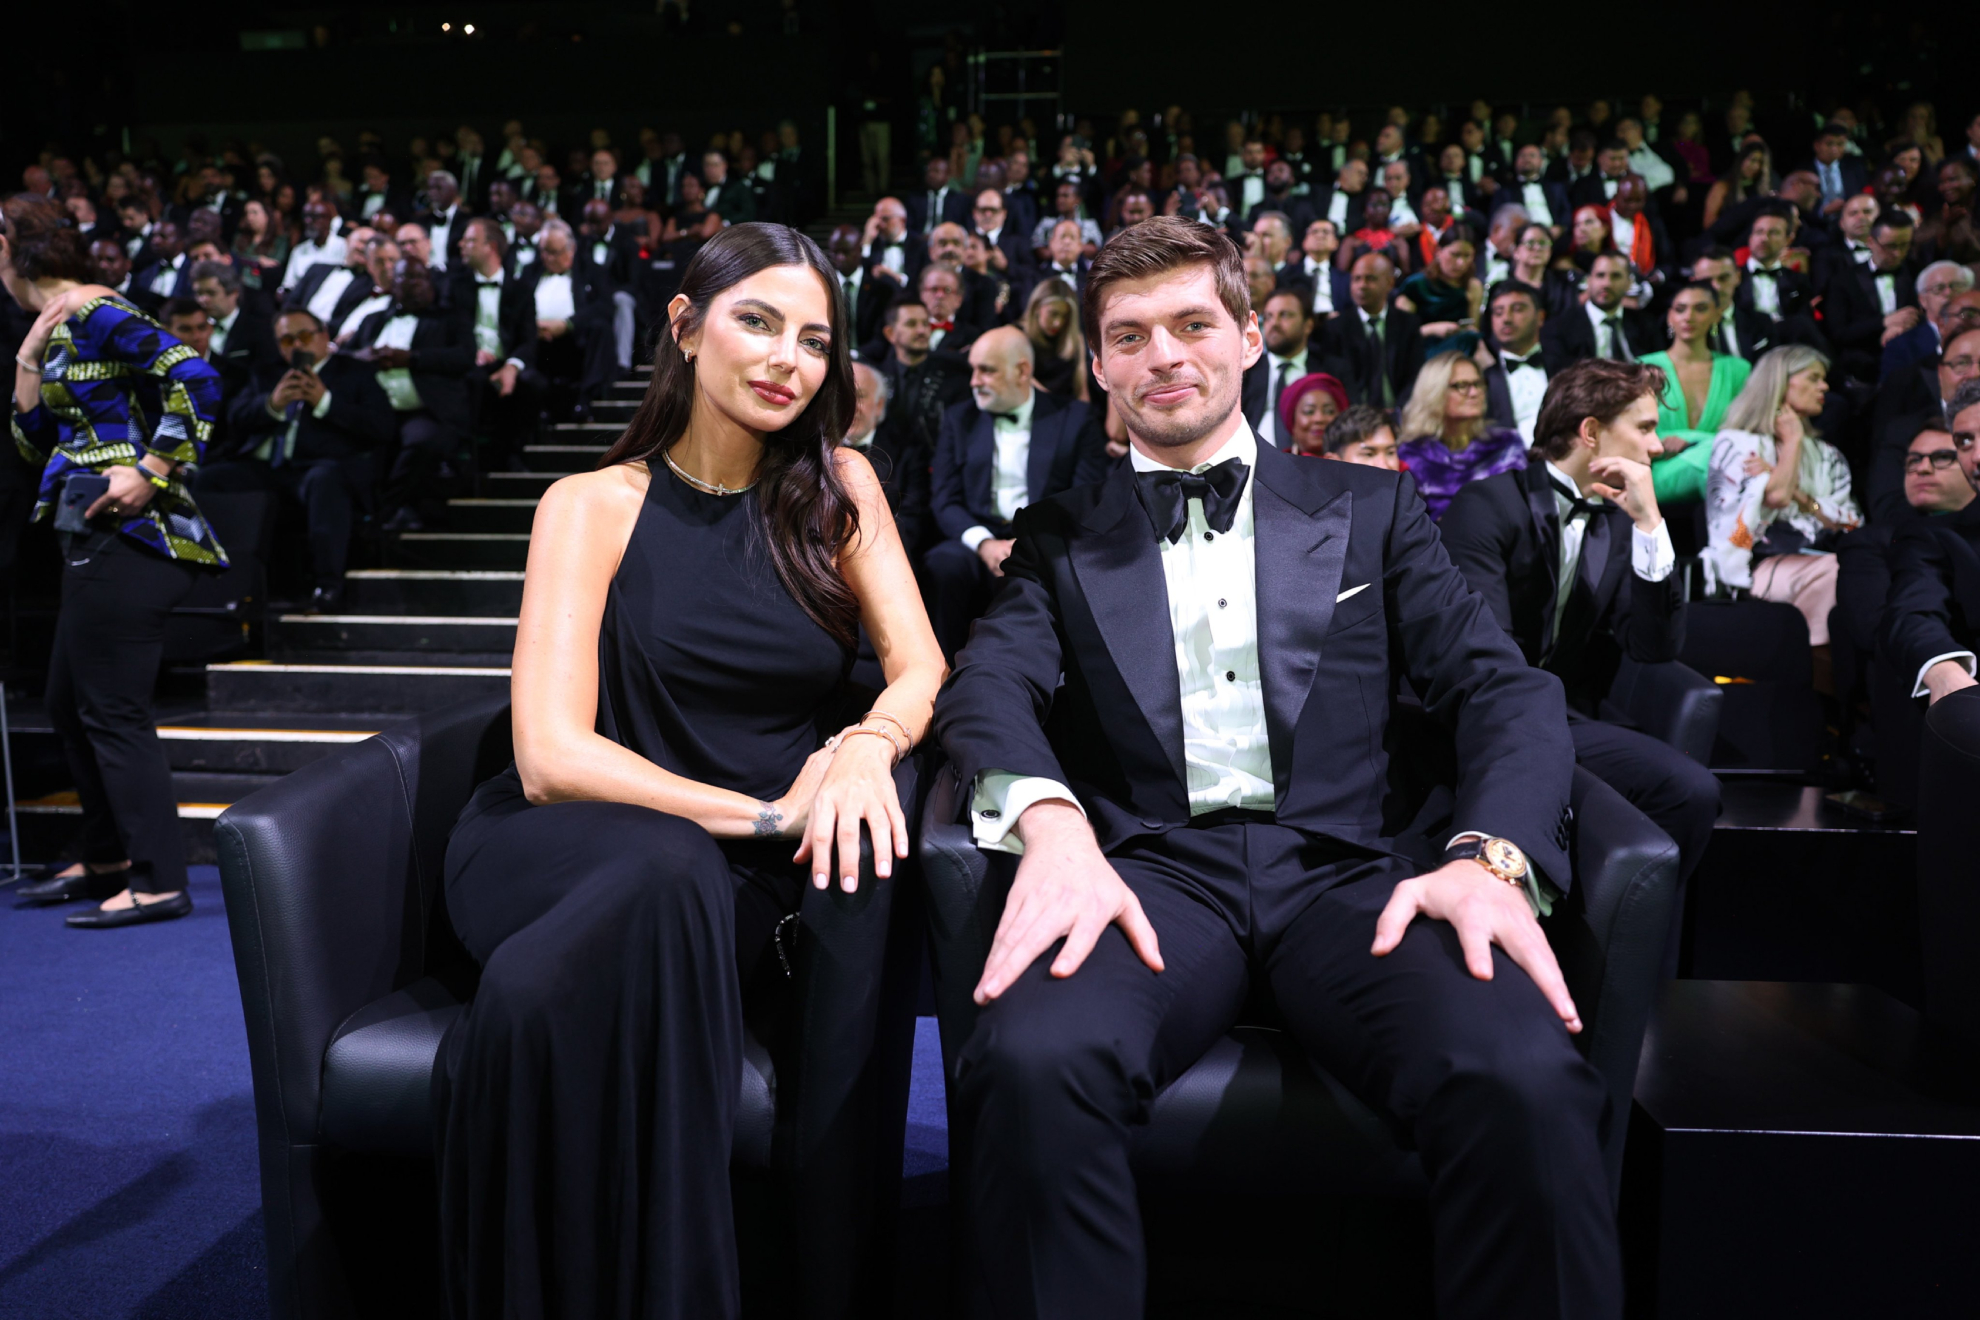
[198,307,398,613]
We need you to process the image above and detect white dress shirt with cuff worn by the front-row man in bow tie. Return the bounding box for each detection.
[970,422,1275,853]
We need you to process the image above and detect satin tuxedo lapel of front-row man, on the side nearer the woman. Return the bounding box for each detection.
[1067,463,1180,792]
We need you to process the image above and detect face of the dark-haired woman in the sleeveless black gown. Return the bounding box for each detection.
[669,265,832,435]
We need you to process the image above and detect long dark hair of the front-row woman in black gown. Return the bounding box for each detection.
[598,222,859,651]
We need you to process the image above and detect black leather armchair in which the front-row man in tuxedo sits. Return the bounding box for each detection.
[921,766,1677,1266]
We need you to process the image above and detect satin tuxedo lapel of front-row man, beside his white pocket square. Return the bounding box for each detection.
[1259,447,1354,800]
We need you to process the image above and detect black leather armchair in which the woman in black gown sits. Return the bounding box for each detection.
[216,699,921,1320]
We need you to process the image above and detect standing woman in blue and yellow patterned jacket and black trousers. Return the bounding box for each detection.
[0,198,226,928]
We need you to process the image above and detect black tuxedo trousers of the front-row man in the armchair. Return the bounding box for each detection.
[956,811,1626,1320]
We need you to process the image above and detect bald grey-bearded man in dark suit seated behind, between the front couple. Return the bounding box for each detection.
[927,325,1107,657]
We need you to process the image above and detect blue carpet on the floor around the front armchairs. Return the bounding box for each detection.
[0,867,948,1320]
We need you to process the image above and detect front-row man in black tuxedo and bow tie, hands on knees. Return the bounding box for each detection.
[935,218,1622,1320]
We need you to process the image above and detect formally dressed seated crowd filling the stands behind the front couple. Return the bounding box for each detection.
[26,93,1980,807]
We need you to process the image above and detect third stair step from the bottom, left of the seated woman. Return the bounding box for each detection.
[206,661,509,714]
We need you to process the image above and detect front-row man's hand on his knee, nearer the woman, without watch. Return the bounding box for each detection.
[976,800,1162,1003]
